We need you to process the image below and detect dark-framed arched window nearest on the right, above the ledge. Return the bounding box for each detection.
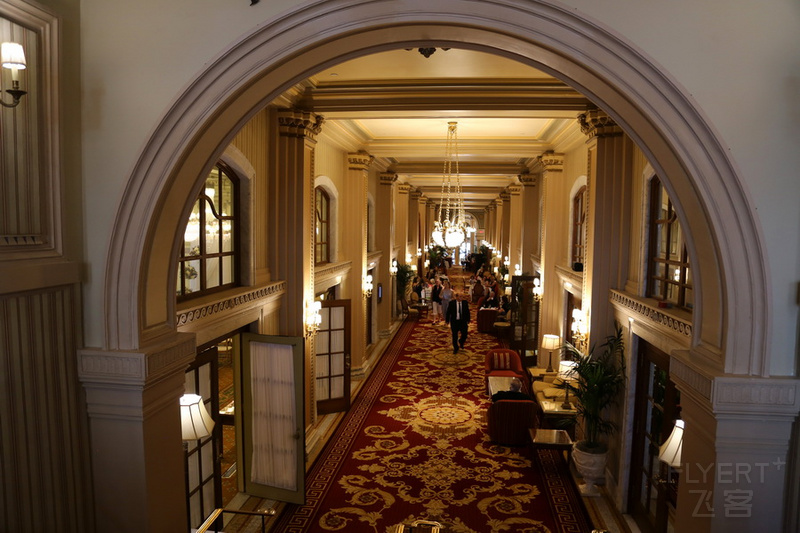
[647,177,694,309]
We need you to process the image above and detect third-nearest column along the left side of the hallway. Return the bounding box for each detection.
[375,172,400,326]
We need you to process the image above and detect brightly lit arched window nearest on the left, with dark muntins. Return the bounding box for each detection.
[177,163,239,300]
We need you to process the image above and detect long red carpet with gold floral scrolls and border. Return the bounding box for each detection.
[273,311,592,533]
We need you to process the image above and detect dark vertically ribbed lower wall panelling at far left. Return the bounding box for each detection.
[0,285,93,532]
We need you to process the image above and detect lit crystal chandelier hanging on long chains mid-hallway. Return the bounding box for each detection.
[431,122,467,248]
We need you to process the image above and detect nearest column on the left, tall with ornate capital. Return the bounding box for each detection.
[269,109,324,425]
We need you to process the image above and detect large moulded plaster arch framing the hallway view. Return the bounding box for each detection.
[105,0,769,375]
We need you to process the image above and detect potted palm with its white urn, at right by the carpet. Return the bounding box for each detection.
[559,328,625,494]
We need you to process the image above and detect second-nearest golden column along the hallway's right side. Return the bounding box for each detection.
[534,152,569,350]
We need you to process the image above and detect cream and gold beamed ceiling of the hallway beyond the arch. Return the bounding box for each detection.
[294,49,591,209]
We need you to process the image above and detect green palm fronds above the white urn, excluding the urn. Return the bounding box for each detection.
[558,328,625,453]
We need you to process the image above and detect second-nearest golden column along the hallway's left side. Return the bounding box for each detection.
[339,152,370,373]
